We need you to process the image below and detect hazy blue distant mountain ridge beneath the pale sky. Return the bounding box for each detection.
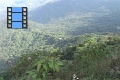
[29,0,120,23]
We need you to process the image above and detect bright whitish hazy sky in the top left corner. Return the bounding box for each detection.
[0,0,58,18]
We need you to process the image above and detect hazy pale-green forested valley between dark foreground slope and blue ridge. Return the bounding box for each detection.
[0,12,120,69]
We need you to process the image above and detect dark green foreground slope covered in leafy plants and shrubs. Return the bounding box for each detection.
[1,34,120,80]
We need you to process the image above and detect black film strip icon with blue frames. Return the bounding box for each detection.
[7,7,28,29]
